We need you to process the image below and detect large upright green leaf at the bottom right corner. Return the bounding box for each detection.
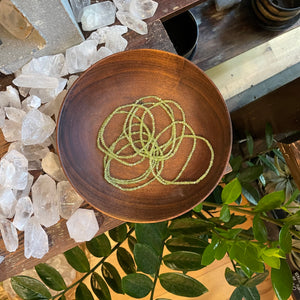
[271,259,293,300]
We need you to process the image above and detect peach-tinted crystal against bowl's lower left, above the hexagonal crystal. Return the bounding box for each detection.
[57,181,83,219]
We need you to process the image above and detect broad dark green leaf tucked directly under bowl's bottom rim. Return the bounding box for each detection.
[135,222,167,255]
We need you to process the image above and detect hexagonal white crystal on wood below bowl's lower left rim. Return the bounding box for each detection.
[66,208,99,243]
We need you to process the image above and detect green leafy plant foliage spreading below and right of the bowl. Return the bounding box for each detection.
[11,126,300,300]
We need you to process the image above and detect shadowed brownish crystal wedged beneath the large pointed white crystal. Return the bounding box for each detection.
[8,141,50,161]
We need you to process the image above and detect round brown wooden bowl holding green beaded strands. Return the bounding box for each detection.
[57,49,232,222]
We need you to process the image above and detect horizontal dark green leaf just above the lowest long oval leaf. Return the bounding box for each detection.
[163,251,204,273]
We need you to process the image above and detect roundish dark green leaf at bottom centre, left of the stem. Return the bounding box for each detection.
[122,273,153,298]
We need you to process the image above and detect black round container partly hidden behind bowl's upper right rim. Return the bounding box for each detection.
[163,11,199,60]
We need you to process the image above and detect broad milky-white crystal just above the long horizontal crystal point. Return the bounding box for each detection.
[22,53,67,77]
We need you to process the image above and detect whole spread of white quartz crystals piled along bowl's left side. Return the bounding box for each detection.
[0,0,158,263]
